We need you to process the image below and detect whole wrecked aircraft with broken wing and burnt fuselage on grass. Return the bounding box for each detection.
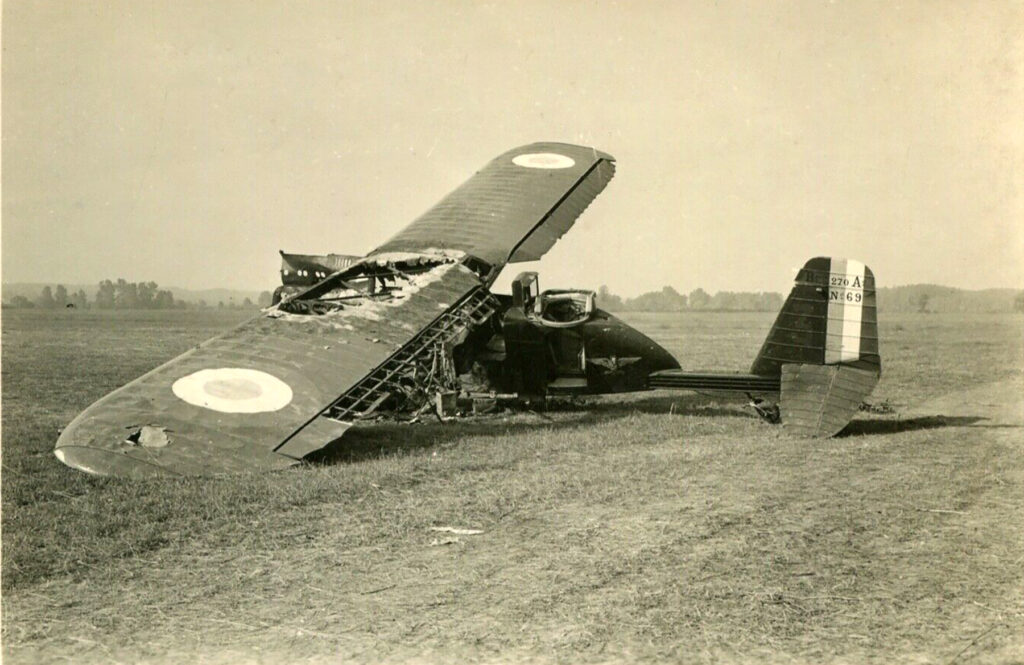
[55,143,881,476]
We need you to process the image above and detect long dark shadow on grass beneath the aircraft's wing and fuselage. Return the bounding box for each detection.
[304,394,756,466]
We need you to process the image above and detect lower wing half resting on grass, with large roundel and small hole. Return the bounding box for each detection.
[55,262,480,475]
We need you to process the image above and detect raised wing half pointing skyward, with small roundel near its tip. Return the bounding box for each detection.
[371,143,615,275]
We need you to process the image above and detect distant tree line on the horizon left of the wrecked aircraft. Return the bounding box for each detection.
[4,278,271,309]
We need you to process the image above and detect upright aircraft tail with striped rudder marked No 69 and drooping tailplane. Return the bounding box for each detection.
[751,257,882,437]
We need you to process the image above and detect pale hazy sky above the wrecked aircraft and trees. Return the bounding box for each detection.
[2,0,1024,295]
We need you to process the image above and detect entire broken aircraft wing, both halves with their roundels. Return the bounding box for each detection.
[54,143,613,476]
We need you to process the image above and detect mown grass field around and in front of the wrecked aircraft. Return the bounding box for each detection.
[2,310,1024,663]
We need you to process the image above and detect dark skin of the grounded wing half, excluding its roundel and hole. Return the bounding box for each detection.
[57,264,479,474]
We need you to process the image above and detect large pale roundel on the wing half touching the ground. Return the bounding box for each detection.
[171,367,292,413]
